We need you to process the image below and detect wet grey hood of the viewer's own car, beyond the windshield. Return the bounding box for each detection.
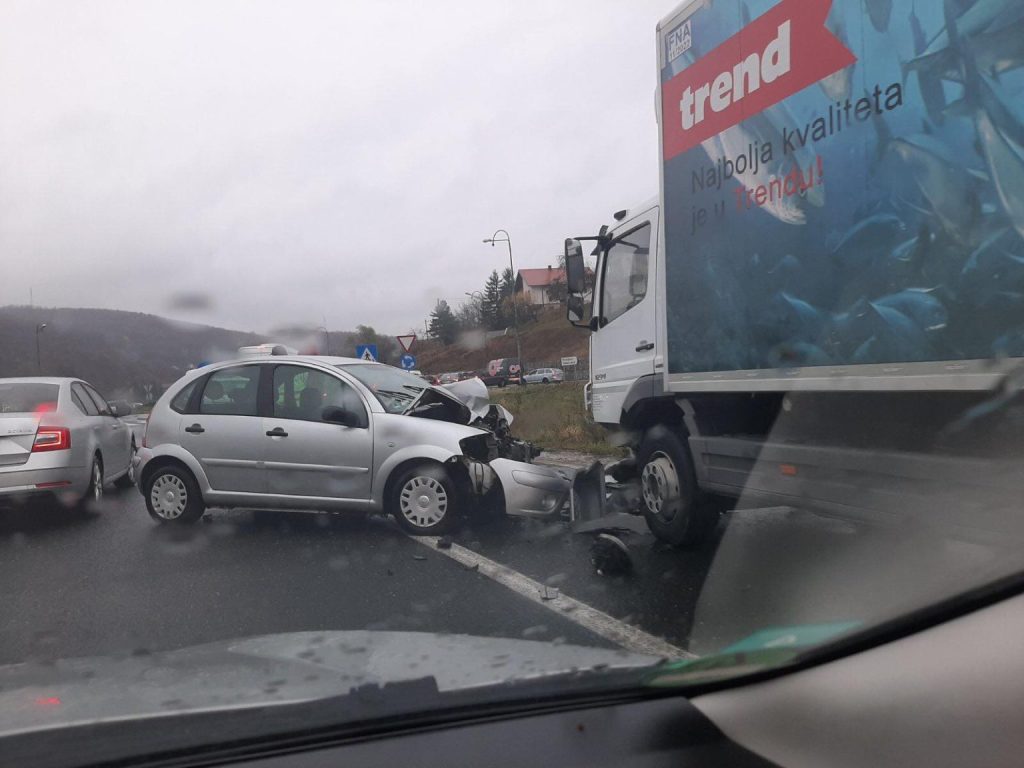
[0,631,658,736]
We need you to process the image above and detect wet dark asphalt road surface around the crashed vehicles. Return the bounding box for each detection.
[0,475,1002,664]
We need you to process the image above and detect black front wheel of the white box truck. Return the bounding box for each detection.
[637,425,718,547]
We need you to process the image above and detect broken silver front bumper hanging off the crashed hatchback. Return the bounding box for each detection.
[469,459,575,517]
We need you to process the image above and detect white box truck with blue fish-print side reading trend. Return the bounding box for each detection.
[565,0,1024,544]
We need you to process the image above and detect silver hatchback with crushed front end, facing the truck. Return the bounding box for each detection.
[135,355,572,534]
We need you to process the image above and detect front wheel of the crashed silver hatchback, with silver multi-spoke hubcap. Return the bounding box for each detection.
[388,464,460,536]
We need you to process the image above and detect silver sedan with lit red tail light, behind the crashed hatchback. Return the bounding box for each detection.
[0,378,135,507]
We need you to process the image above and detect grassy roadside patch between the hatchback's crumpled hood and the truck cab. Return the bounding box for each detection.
[489,381,622,456]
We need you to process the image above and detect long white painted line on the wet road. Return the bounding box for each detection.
[410,536,697,658]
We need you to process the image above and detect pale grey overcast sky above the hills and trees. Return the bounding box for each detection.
[0,0,674,332]
